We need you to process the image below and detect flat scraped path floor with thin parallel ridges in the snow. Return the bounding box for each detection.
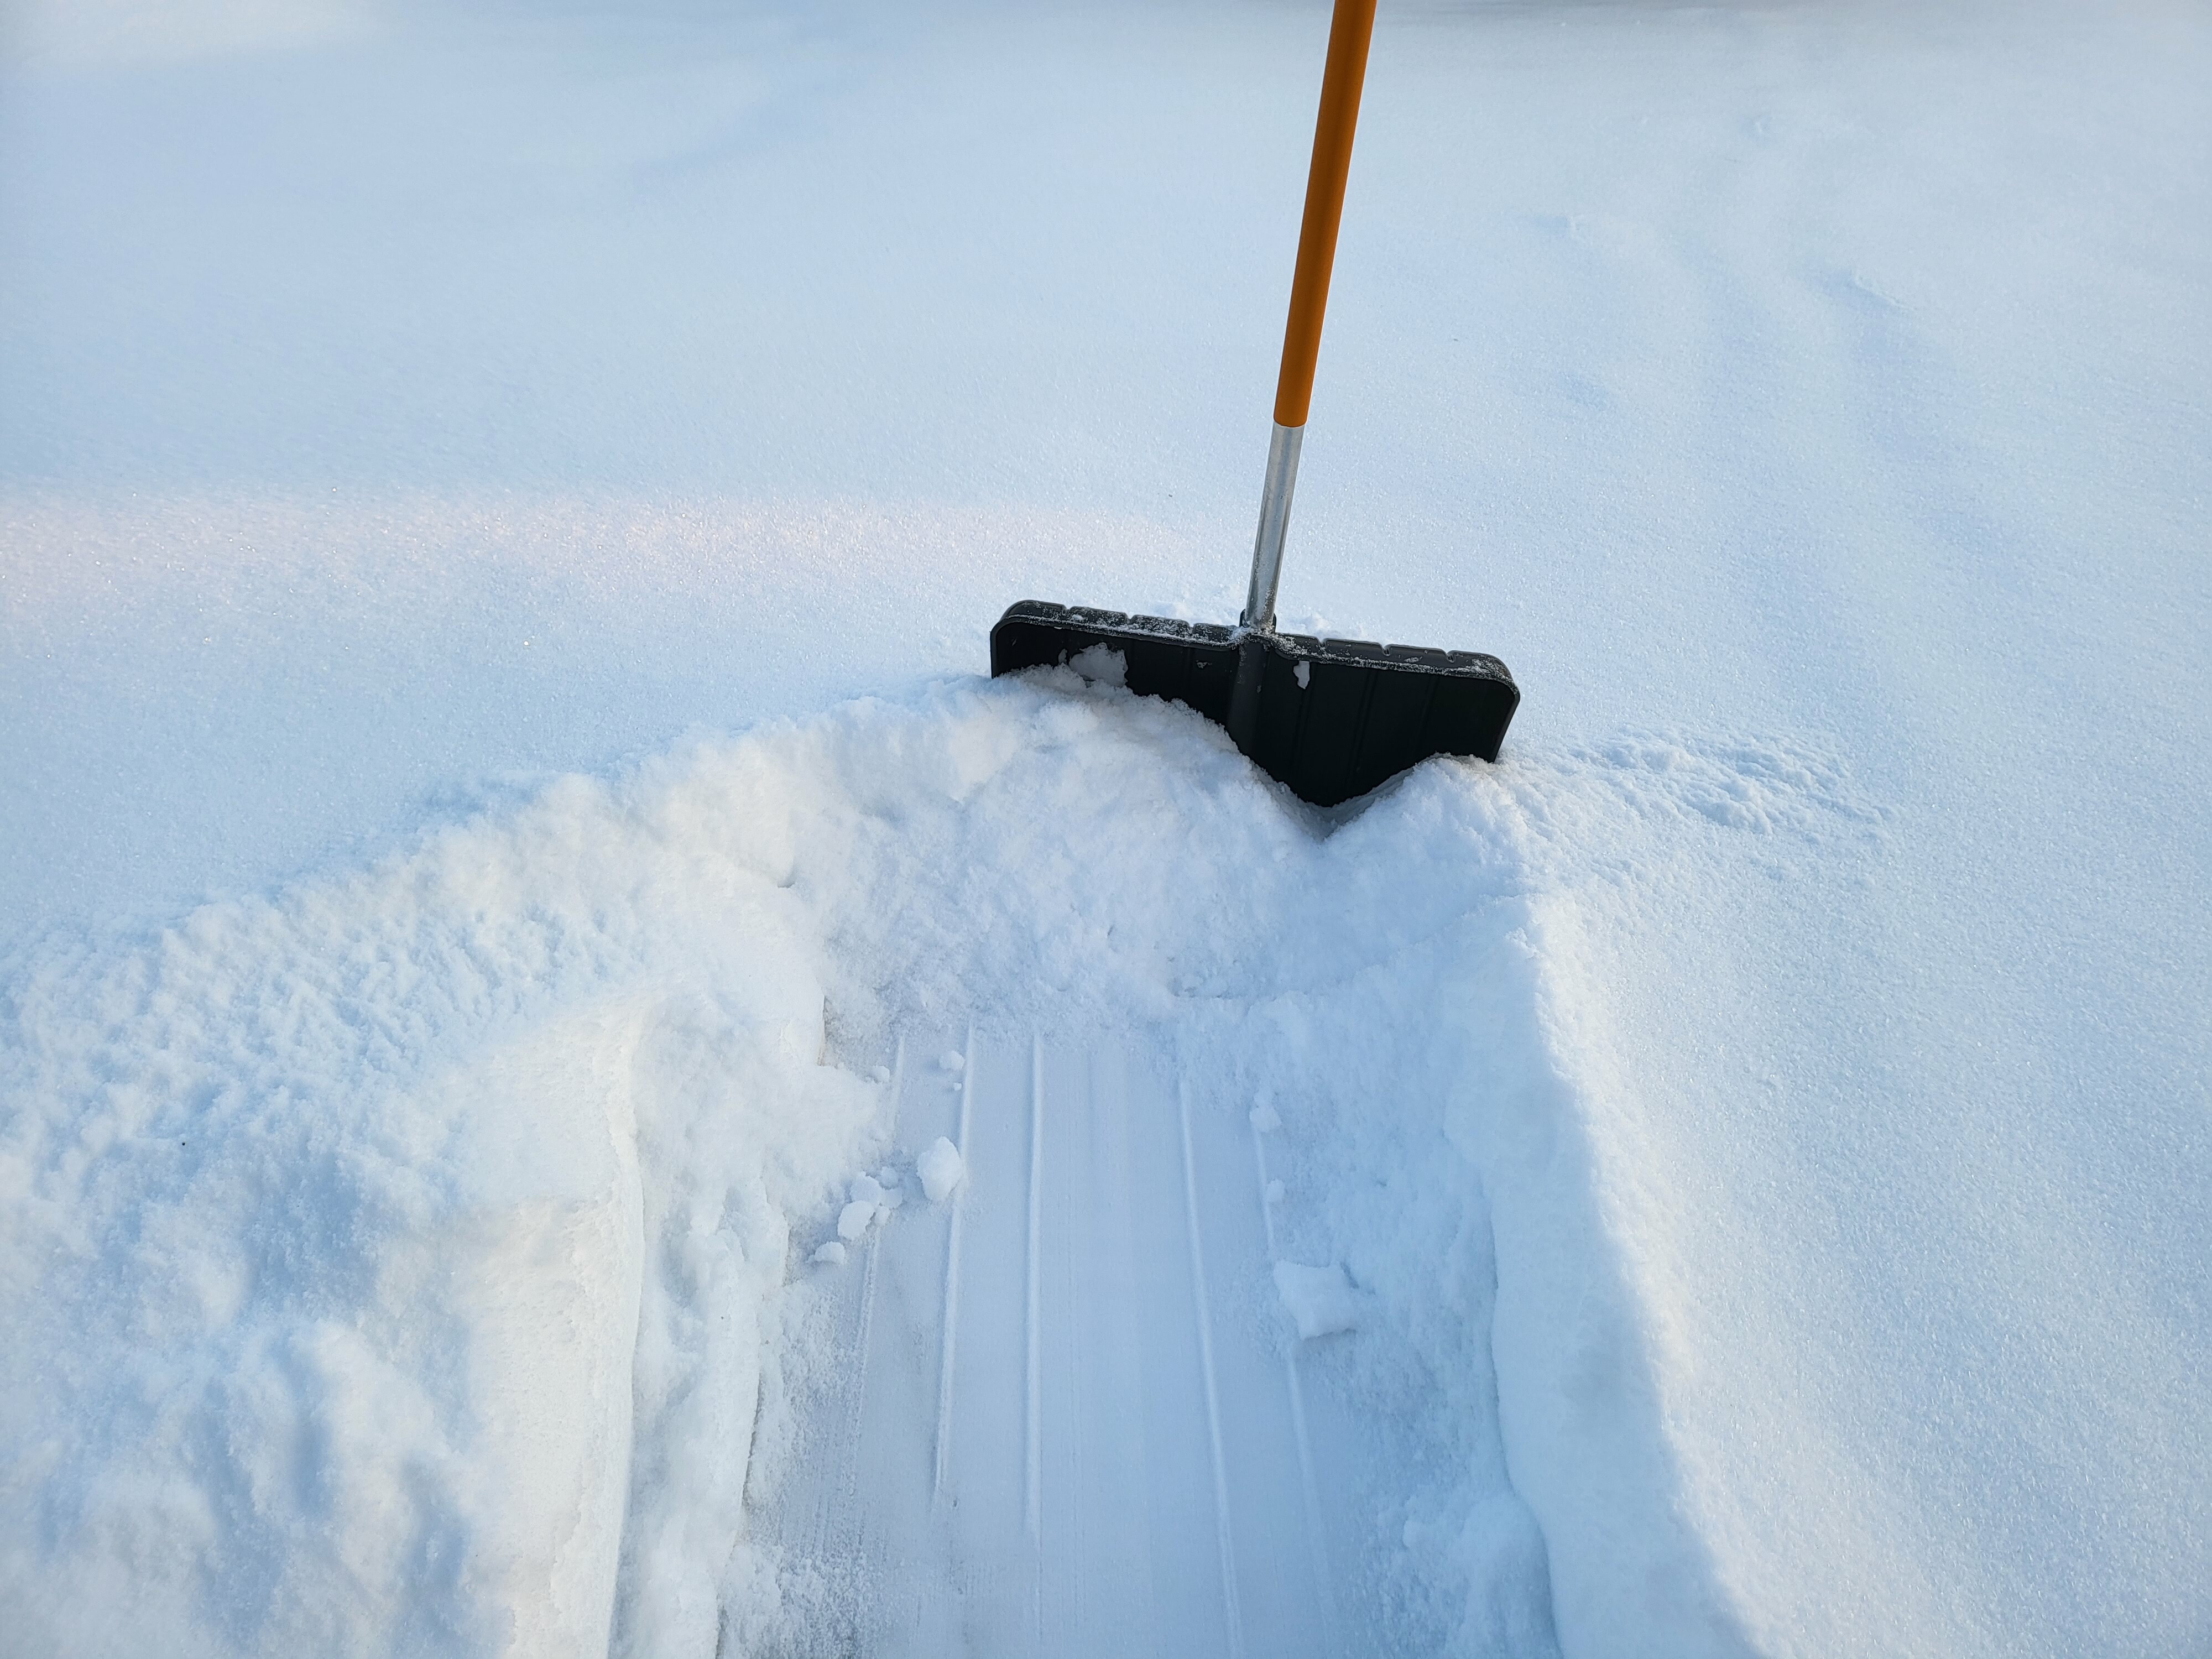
[759,1037,1391,1655]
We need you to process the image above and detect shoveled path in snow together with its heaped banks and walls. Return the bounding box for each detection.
[0,670,1871,1659]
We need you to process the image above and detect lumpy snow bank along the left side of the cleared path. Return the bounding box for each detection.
[0,721,878,1652]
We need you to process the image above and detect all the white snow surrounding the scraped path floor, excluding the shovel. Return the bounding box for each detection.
[0,0,2212,1655]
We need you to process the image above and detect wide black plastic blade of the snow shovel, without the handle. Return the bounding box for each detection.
[991,599,1520,807]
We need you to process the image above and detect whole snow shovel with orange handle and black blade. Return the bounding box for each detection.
[991,0,1520,807]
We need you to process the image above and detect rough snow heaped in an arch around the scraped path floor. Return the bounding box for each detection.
[0,672,1876,1655]
